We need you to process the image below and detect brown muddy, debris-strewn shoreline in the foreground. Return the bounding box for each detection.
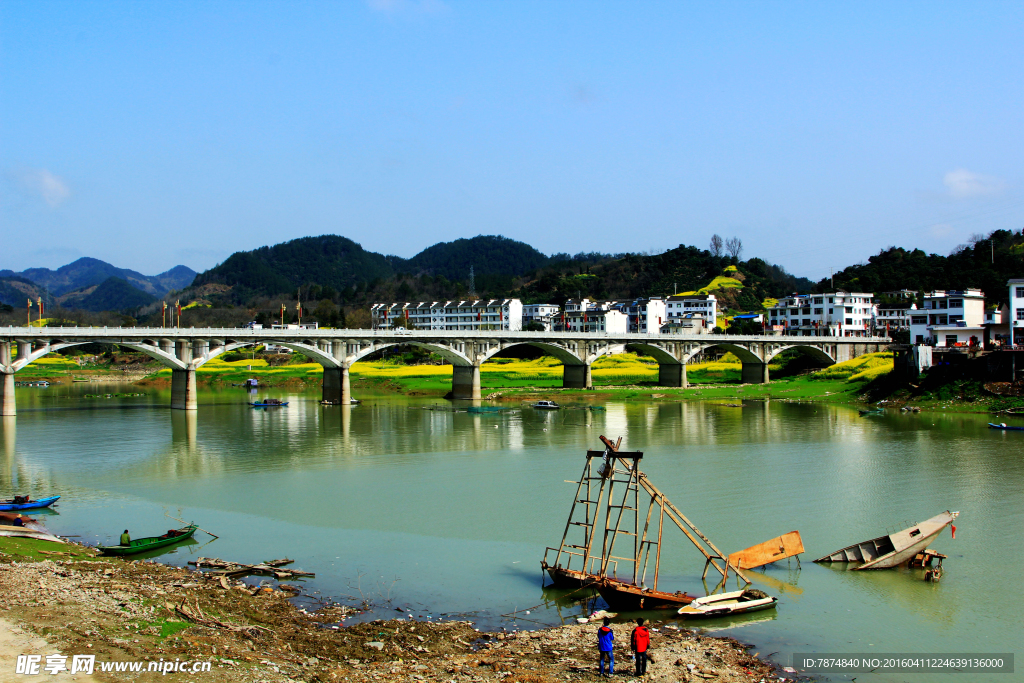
[0,539,794,683]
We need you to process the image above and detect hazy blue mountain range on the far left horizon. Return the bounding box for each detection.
[0,257,196,297]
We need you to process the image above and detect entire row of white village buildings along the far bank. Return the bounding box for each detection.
[371,279,1024,346]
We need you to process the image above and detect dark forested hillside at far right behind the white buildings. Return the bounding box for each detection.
[815,230,1024,304]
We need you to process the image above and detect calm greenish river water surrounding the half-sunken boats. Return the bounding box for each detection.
[0,384,1024,681]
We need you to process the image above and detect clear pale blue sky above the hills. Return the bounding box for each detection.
[0,0,1024,278]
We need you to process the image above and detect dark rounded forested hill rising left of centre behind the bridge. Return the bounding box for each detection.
[193,234,400,299]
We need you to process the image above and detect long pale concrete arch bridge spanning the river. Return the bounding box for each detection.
[0,328,891,415]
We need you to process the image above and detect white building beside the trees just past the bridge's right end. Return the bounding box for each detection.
[910,289,985,346]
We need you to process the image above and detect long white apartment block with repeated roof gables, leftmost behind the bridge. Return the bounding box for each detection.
[370,299,522,331]
